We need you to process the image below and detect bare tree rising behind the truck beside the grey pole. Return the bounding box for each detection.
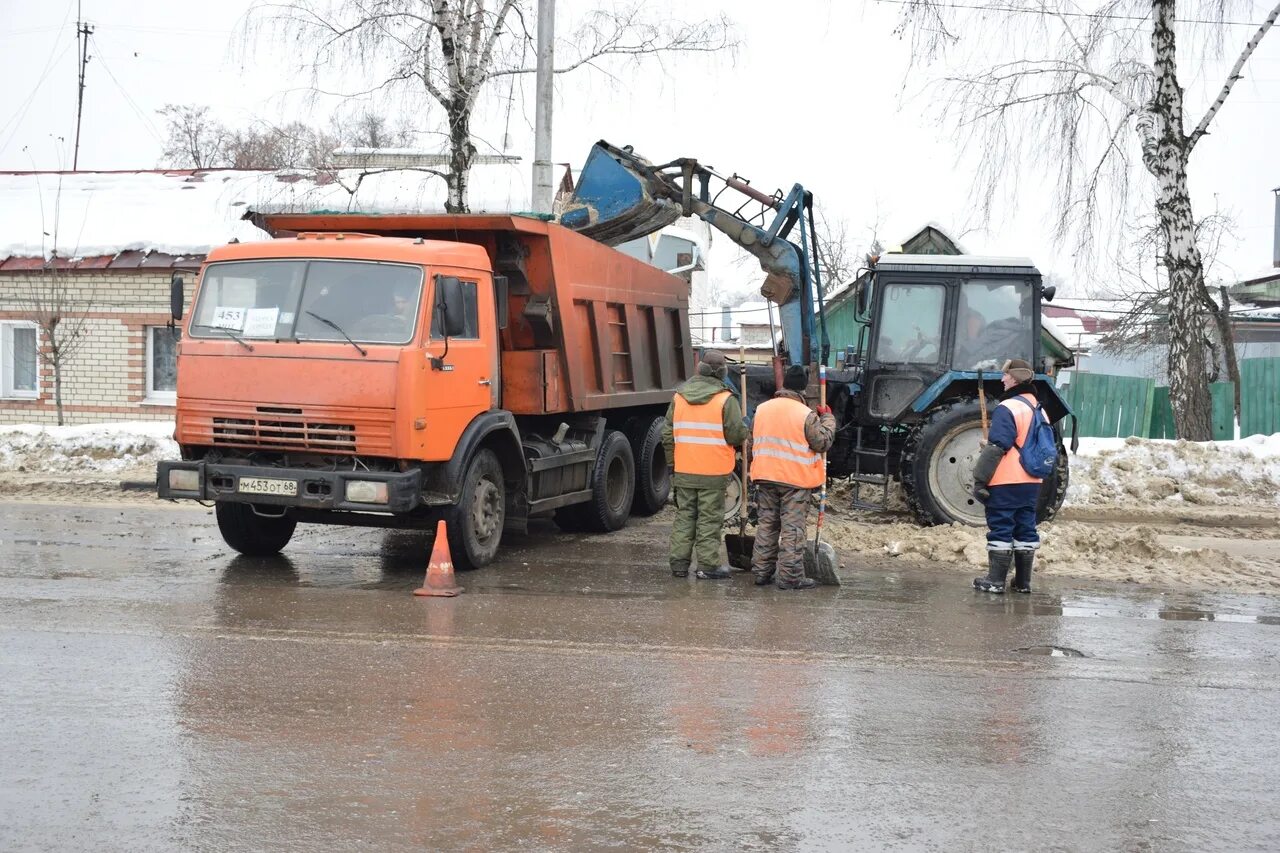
[246,0,733,213]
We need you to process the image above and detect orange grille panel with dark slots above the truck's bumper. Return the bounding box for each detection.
[178,400,396,456]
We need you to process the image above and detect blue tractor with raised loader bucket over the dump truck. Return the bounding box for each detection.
[561,141,1074,525]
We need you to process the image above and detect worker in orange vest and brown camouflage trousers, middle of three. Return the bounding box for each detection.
[751,364,836,589]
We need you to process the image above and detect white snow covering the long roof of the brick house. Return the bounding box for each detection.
[0,163,530,257]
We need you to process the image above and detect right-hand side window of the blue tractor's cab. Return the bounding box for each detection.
[952,279,1032,370]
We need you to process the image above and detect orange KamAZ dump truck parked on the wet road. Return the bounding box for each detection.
[157,214,694,566]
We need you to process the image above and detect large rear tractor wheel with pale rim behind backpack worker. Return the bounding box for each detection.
[899,400,995,526]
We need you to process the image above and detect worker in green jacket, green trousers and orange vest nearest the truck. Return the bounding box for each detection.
[662,350,746,580]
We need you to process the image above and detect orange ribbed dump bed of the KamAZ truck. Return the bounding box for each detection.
[250,214,694,414]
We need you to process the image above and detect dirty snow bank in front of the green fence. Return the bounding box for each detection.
[1066,433,1280,506]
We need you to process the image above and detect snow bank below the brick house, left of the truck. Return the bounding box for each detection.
[0,421,178,474]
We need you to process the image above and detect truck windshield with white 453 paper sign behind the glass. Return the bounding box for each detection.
[191,260,422,343]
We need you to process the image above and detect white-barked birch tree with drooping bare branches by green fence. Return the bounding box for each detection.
[901,0,1280,441]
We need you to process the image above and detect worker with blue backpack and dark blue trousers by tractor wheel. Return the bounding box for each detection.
[973,359,1043,596]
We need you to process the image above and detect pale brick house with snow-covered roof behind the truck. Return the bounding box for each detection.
[0,161,552,424]
